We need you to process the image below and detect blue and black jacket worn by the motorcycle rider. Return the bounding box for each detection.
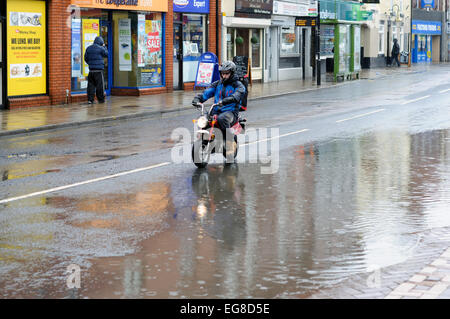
[200,74,245,113]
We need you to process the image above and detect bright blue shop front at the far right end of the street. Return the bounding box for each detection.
[411,20,442,63]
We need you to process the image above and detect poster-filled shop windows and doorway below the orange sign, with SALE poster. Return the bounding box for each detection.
[72,8,163,92]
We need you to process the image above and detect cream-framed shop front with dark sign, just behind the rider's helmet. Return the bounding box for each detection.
[224,0,273,81]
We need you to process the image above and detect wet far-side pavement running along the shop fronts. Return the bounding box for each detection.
[0,66,423,136]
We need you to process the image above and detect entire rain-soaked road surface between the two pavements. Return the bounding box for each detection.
[0,68,450,298]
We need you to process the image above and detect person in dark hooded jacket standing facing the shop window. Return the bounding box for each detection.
[84,37,108,104]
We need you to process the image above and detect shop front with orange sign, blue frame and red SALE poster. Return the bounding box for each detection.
[71,0,168,96]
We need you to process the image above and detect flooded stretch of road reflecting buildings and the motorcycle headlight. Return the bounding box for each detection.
[0,126,450,298]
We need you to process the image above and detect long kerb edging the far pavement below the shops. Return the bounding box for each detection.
[0,81,354,137]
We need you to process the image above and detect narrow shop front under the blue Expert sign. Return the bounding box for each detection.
[173,0,210,90]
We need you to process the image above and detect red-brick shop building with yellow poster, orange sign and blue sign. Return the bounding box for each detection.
[0,0,221,108]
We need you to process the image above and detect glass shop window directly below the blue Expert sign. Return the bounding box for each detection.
[183,14,206,82]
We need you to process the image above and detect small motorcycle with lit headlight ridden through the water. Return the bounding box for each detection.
[192,103,247,168]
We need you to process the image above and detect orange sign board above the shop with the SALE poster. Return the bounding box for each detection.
[71,0,168,12]
